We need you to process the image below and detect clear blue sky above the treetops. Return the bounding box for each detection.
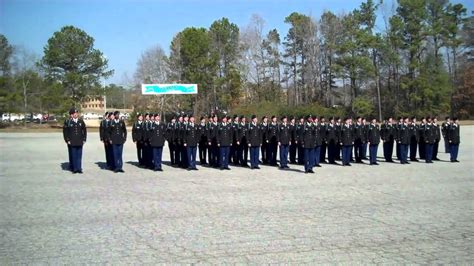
[0,0,474,84]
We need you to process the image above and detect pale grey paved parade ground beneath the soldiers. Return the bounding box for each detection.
[0,126,474,265]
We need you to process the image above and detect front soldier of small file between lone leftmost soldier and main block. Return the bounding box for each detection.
[107,111,127,173]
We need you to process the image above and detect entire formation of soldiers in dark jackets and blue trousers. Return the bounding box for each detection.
[63,108,460,173]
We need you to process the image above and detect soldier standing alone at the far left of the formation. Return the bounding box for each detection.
[66,108,87,174]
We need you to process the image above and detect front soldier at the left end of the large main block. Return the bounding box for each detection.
[147,114,167,172]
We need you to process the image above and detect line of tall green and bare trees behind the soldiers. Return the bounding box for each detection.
[0,0,474,118]
